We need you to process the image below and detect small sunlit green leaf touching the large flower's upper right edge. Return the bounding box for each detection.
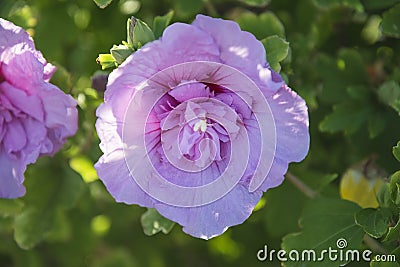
[261,35,289,72]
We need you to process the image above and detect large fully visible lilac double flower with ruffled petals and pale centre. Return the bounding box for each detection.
[96,15,309,239]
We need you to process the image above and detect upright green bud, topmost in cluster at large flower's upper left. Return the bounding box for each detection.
[127,17,155,49]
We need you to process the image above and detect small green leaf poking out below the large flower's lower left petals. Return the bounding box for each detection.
[140,209,175,236]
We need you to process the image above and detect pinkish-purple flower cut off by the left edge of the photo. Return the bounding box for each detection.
[0,18,77,198]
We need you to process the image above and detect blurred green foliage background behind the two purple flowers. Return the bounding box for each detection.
[0,0,400,267]
